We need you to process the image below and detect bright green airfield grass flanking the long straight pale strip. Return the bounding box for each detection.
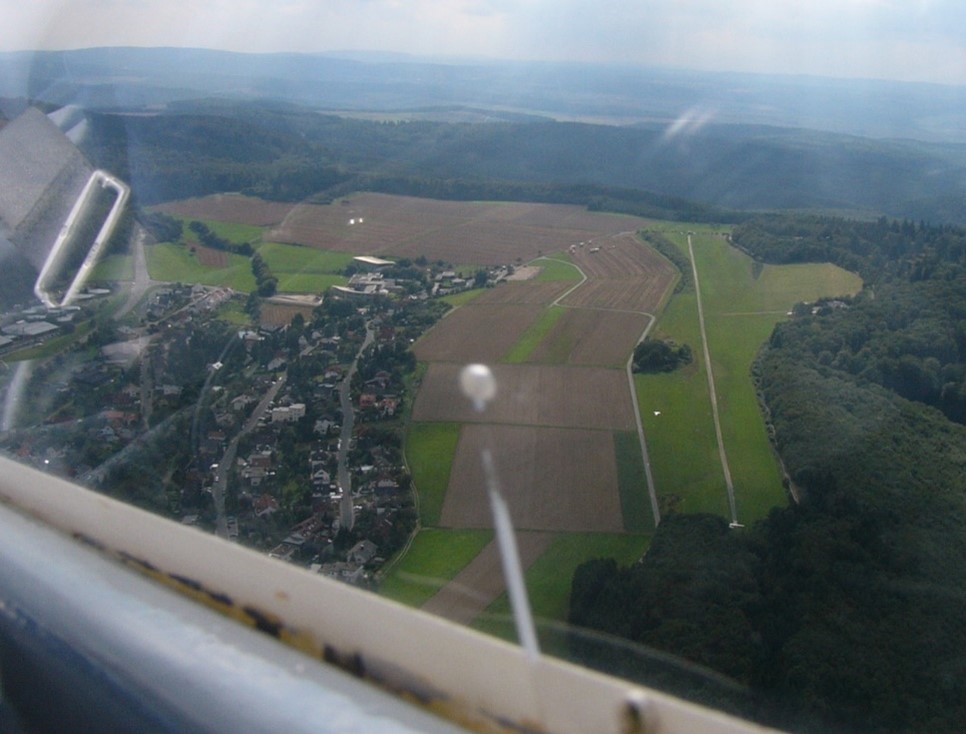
[636,229,861,522]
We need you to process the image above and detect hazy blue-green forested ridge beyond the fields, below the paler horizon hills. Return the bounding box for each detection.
[79,101,966,222]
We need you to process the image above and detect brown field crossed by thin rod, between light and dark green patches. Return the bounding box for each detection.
[441,426,624,533]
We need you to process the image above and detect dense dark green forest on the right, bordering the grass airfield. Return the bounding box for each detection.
[570,216,966,732]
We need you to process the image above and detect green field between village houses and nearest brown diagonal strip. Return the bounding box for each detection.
[379,528,493,607]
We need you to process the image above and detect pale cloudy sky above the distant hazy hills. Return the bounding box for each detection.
[0,0,966,85]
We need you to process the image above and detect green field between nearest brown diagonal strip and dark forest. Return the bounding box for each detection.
[473,533,650,652]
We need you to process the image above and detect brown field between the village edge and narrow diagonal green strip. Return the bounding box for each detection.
[413,304,542,364]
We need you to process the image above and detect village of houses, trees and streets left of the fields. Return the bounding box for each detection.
[0,258,472,586]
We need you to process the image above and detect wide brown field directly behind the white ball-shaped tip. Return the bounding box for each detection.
[413,363,636,432]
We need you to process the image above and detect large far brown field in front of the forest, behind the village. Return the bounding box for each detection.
[266,193,646,265]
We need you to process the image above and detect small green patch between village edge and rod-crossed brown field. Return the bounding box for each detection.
[406,423,460,527]
